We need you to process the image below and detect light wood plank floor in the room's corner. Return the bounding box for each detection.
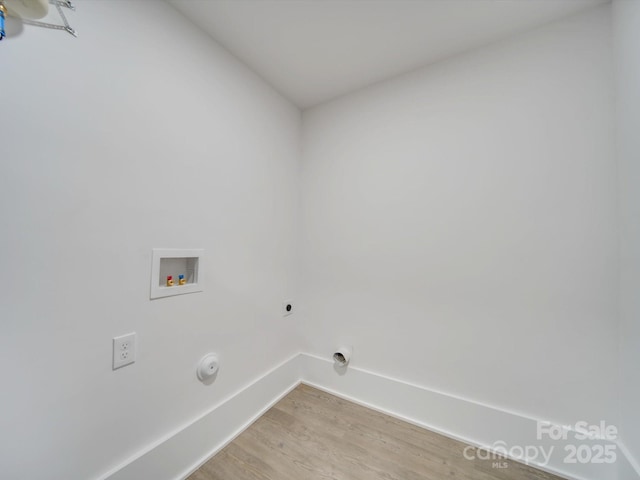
[188,385,561,480]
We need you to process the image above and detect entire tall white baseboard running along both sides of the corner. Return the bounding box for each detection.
[100,354,624,480]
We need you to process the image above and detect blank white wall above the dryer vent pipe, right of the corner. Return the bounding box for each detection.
[301,6,618,428]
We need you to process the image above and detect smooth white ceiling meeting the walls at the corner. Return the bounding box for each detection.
[170,0,608,108]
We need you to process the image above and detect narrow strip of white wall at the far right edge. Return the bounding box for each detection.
[613,0,640,480]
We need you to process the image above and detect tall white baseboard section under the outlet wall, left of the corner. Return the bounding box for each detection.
[101,355,300,480]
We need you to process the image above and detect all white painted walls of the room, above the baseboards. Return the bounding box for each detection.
[0,2,640,480]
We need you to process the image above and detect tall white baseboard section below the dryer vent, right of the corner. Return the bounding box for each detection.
[300,354,621,480]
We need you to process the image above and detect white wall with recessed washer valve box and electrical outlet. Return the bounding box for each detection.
[0,1,300,480]
